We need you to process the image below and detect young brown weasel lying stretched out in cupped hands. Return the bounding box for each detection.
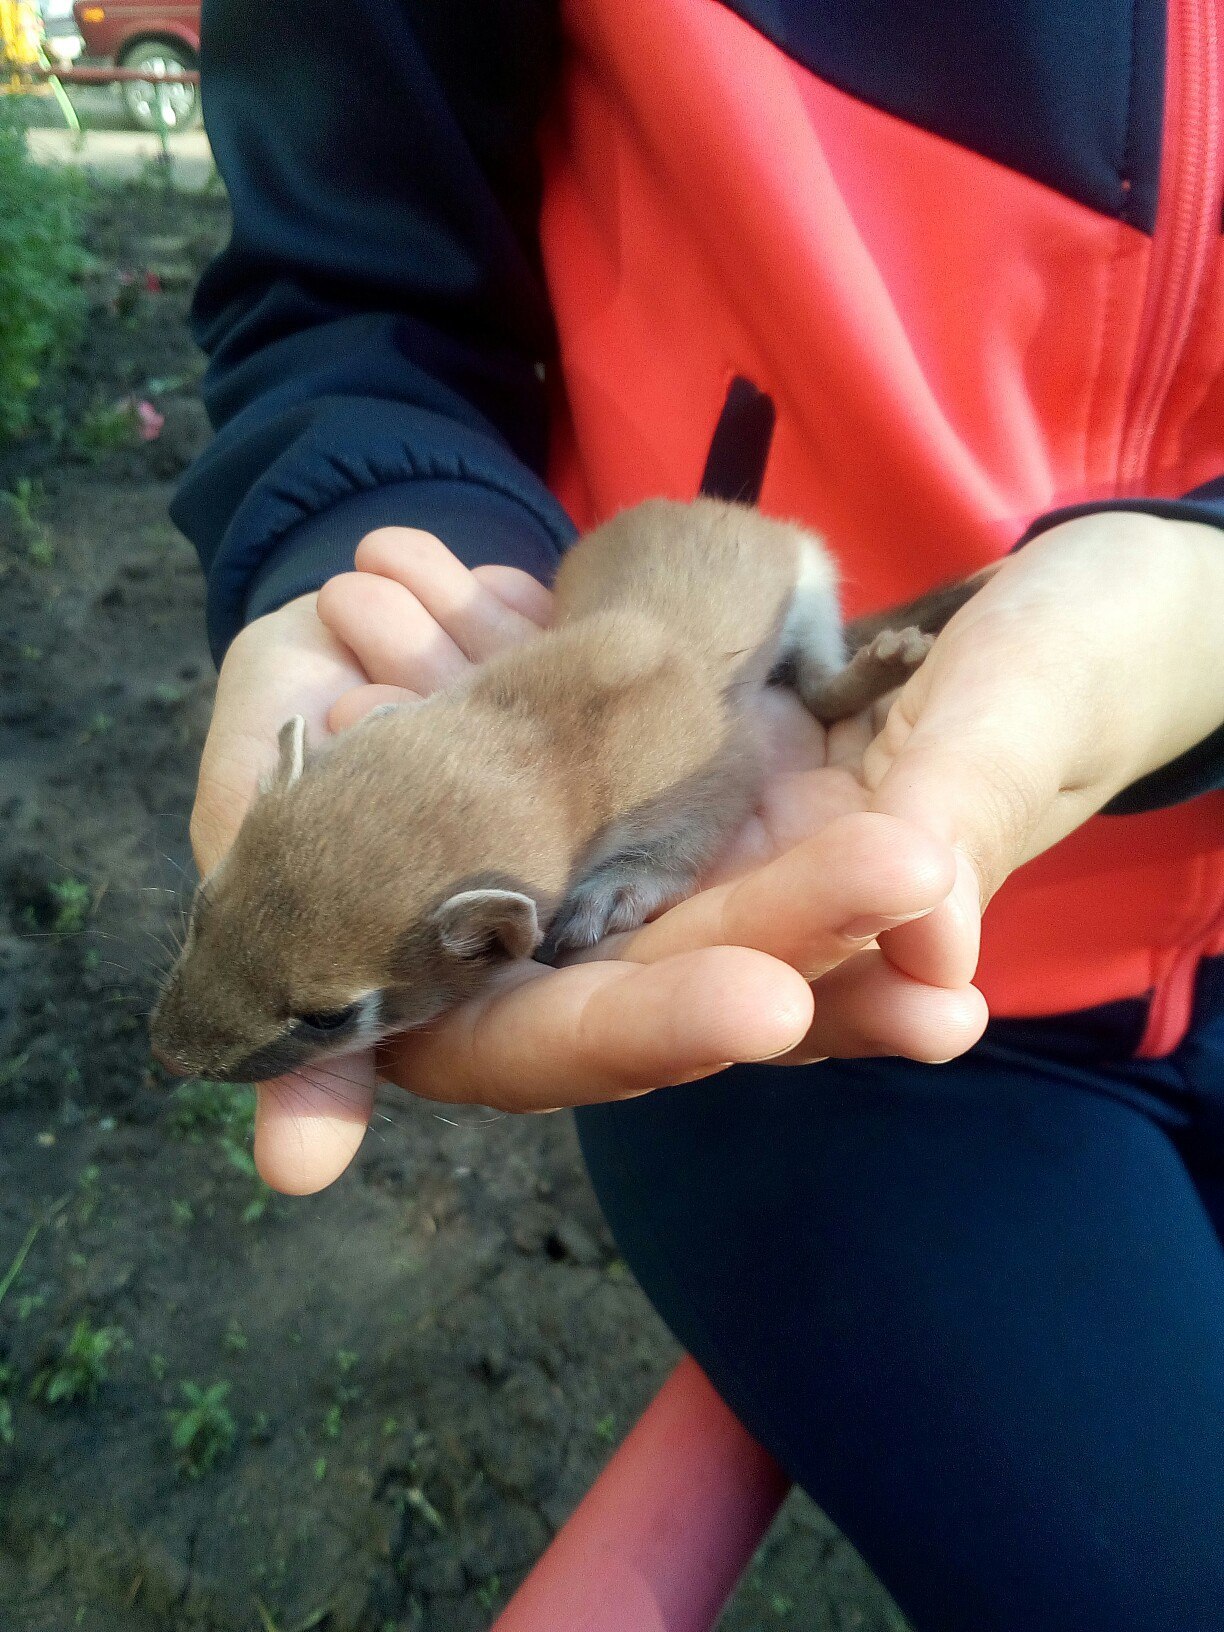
[152,498,991,1082]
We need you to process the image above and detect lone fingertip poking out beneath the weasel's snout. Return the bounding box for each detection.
[255,1053,375,1196]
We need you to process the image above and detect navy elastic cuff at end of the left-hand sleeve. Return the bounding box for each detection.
[243,478,574,623]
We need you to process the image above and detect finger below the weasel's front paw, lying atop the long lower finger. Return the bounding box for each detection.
[619,811,955,979]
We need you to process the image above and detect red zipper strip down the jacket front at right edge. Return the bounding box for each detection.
[1118,0,1224,1059]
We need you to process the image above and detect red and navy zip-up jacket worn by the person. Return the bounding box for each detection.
[176,0,1224,1053]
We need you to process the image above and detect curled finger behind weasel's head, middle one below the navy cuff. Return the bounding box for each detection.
[318,573,468,692]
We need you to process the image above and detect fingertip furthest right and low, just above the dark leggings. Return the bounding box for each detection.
[778,948,989,1066]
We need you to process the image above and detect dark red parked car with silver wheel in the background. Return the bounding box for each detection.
[72,0,199,131]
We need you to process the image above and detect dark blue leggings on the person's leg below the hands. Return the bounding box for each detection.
[579,960,1224,1632]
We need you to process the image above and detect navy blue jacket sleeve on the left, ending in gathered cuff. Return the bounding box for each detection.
[173,0,573,658]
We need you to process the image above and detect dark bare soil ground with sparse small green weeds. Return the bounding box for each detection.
[0,184,902,1632]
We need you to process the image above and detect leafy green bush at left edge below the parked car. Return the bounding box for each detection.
[0,119,86,442]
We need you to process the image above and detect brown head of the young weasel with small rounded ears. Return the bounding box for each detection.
[150,720,542,1082]
